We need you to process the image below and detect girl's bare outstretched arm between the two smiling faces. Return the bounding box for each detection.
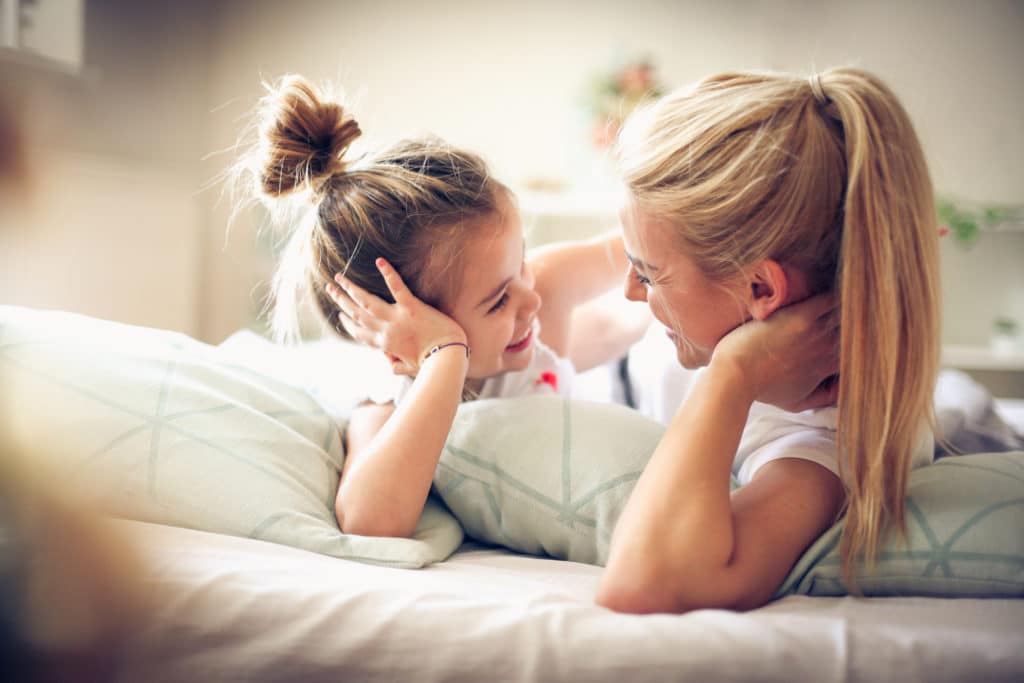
[529,229,650,370]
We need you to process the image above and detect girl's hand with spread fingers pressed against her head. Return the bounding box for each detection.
[327,258,466,375]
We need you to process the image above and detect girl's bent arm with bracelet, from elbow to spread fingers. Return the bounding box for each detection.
[329,262,469,537]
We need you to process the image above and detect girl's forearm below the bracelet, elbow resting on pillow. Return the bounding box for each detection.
[335,346,469,537]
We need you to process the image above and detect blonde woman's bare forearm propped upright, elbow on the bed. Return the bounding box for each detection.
[598,365,754,611]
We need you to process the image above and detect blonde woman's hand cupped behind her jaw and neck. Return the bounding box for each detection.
[712,294,839,412]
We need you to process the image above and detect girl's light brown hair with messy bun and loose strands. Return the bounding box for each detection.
[234,75,511,339]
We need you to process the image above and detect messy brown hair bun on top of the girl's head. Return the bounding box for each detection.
[257,76,361,197]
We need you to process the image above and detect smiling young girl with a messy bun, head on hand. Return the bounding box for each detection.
[243,77,643,537]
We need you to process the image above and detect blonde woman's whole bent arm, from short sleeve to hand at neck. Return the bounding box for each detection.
[597,300,843,612]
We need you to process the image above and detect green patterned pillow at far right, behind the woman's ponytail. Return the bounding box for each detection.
[778,451,1024,597]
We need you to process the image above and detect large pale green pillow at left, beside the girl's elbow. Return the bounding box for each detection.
[0,306,462,567]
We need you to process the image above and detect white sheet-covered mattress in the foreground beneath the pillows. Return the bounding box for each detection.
[119,522,1024,683]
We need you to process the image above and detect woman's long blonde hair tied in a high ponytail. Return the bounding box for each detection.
[617,69,939,583]
